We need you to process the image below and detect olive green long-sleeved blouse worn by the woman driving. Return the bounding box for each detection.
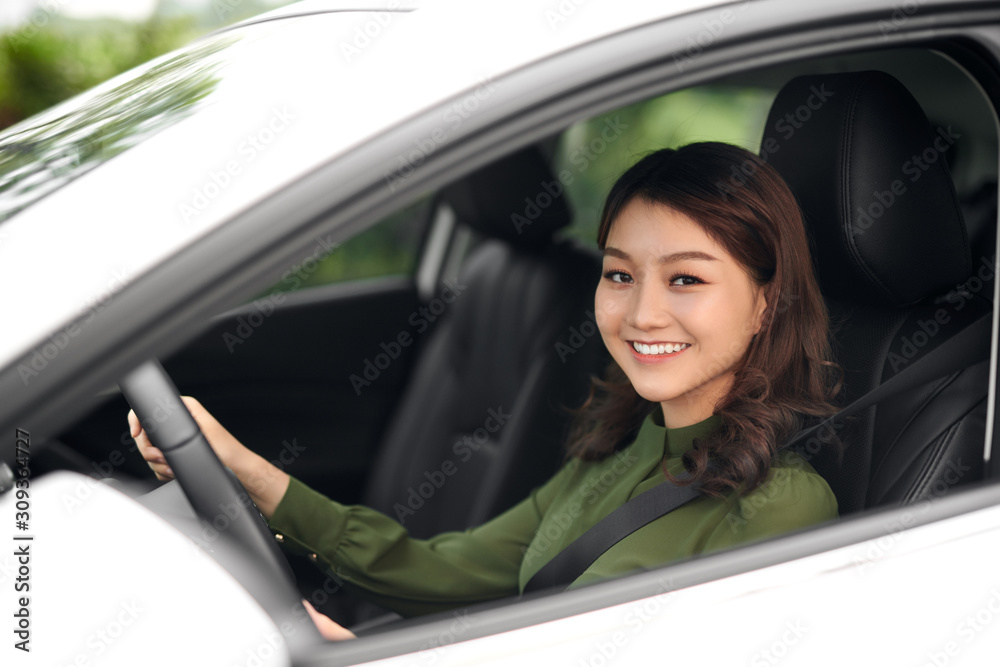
[270,407,837,616]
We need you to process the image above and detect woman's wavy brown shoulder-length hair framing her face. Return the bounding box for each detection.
[568,142,843,496]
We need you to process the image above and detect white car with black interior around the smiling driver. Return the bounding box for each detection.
[0,0,1000,667]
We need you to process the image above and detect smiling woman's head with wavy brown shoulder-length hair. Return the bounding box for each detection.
[572,142,839,495]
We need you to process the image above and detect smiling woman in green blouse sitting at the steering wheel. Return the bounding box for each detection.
[129,143,837,636]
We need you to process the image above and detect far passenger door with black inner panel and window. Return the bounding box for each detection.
[55,197,449,501]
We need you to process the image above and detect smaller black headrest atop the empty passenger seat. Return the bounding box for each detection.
[443,146,573,246]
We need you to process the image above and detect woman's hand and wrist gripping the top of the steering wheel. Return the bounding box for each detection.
[128,396,290,516]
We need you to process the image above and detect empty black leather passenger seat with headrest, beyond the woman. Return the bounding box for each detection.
[364,148,603,537]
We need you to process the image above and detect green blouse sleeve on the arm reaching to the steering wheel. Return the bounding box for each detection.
[269,466,569,616]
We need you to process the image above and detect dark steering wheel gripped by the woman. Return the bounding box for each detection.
[118,359,325,654]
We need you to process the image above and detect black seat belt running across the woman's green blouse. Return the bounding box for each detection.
[524,312,993,593]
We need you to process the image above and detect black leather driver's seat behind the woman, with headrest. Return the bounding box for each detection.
[761,71,992,514]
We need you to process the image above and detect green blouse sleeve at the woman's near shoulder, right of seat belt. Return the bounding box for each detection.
[705,452,837,552]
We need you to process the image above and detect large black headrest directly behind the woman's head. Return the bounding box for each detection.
[761,71,972,306]
